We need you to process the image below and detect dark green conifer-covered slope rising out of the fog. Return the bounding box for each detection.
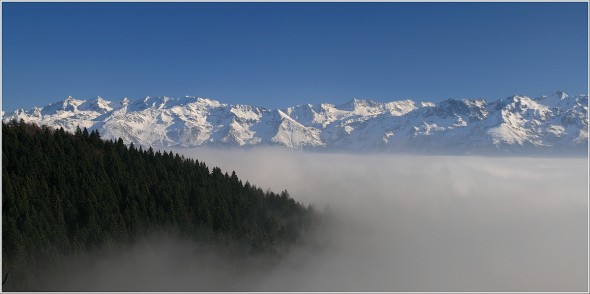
[2,121,318,291]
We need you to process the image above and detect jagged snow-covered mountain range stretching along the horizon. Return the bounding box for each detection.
[2,92,588,154]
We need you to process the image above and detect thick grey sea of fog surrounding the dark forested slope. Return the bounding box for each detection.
[3,122,588,292]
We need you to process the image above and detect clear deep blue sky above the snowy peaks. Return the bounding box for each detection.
[2,3,588,111]
